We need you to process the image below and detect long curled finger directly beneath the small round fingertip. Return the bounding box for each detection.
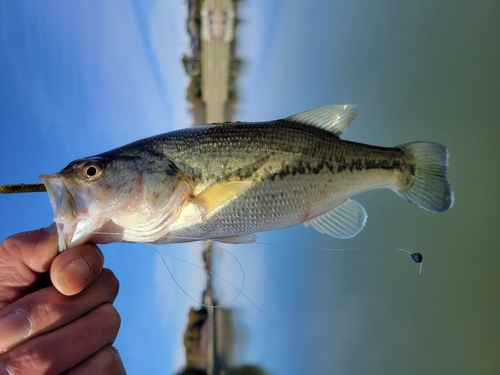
[0,269,118,353]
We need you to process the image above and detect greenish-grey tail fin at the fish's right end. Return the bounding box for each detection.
[396,142,453,212]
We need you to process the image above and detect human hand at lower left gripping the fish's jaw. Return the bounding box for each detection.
[0,226,125,375]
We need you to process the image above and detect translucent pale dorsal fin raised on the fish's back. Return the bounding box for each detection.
[286,104,358,136]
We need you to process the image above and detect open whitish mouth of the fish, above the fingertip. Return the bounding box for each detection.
[40,174,103,252]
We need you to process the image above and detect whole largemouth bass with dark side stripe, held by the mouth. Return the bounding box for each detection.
[40,104,454,251]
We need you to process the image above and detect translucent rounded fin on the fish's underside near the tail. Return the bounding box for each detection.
[305,199,367,239]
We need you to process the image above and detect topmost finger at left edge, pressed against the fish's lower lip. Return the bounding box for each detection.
[0,225,57,308]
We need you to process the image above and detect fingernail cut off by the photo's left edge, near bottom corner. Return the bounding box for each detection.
[0,310,33,352]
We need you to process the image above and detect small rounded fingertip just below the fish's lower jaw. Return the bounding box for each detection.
[50,243,104,296]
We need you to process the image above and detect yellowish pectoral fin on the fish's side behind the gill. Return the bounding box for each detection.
[191,181,252,216]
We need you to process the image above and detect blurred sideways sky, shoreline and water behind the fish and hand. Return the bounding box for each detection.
[0,0,500,374]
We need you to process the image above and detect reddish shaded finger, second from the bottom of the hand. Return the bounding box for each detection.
[0,303,120,375]
